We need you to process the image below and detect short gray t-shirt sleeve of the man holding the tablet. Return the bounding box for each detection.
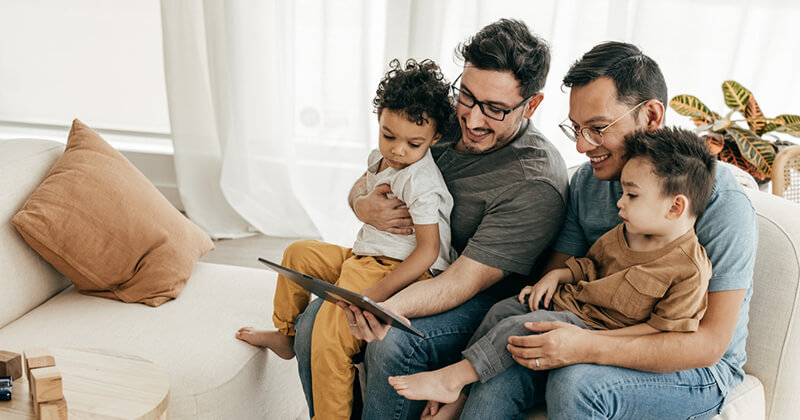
[462,180,565,275]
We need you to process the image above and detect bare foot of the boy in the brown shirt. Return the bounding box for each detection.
[389,360,478,403]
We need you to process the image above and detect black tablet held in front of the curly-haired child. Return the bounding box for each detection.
[258,258,425,338]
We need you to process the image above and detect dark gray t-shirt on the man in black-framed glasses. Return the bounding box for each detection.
[431,120,568,286]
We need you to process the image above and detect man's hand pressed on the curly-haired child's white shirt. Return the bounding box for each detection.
[353,184,414,235]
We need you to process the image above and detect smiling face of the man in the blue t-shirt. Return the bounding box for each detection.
[569,77,648,181]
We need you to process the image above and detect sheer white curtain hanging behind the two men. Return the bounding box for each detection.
[161,0,800,245]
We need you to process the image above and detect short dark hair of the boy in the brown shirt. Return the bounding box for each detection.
[625,127,716,217]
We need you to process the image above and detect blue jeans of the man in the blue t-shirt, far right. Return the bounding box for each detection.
[462,364,723,420]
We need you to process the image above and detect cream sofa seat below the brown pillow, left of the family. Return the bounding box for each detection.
[0,262,308,420]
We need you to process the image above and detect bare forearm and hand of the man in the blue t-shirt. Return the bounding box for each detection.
[508,290,747,372]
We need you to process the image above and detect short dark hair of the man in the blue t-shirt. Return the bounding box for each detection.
[564,41,668,115]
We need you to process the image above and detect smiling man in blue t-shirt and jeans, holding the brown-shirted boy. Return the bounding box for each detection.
[463,42,758,419]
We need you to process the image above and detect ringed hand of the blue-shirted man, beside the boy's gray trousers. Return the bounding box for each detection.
[506,321,591,370]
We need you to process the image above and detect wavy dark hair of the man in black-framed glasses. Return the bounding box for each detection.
[456,19,550,98]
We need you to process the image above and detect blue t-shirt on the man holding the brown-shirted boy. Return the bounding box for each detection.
[553,162,758,394]
